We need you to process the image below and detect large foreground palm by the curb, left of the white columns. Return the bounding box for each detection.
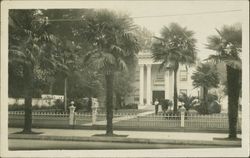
[80,10,139,136]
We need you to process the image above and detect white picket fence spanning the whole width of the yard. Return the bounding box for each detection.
[9,111,242,131]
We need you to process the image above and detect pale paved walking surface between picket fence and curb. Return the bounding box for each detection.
[8,128,241,145]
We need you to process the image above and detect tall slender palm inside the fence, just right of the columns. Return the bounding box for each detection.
[152,23,196,113]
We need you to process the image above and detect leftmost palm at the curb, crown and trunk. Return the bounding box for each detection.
[9,10,57,133]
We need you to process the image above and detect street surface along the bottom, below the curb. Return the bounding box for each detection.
[9,139,233,150]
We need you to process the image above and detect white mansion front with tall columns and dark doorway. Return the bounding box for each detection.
[125,52,200,109]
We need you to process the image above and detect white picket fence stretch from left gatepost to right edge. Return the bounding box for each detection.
[75,112,241,130]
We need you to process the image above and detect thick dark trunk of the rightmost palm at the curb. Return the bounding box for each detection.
[227,65,241,139]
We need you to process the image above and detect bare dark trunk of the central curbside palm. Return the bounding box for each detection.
[105,74,114,136]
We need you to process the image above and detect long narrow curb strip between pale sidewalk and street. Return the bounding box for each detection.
[8,134,241,147]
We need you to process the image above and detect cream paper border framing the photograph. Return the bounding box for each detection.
[0,1,249,157]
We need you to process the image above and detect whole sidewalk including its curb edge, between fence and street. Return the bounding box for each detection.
[9,128,241,147]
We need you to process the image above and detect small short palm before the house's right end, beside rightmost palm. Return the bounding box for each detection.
[191,63,220,114]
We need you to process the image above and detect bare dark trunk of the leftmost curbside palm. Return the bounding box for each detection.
[23,65,34,133]
